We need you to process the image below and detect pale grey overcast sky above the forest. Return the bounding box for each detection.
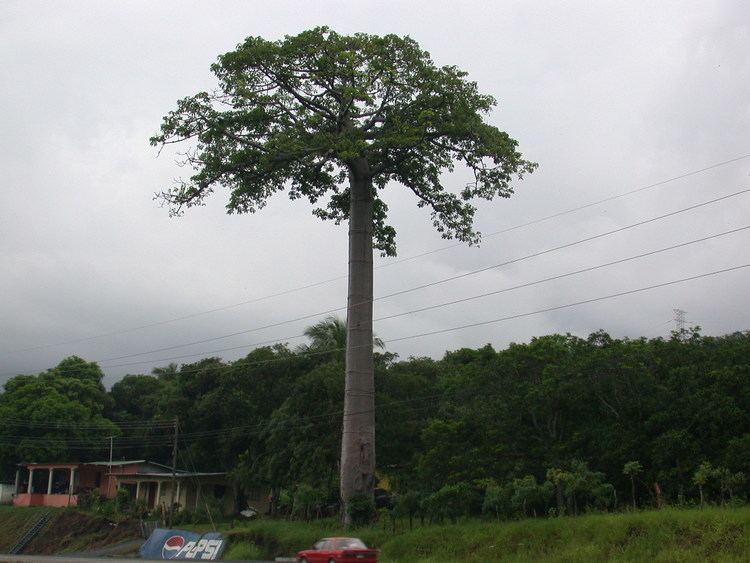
[0,0,750,384]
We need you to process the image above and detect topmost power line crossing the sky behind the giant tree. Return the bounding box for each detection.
[0,154,750,355]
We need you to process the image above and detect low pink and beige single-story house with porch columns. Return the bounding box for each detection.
[13,459,268,514]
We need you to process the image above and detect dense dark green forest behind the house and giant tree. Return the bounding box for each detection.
[0,326,750,520]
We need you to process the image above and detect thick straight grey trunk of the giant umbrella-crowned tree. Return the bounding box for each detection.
[341,159,375,525]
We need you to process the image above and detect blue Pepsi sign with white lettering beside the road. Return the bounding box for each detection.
[139,528,226,561]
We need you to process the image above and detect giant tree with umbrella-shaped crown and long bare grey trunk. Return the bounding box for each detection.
[151,27,535,519]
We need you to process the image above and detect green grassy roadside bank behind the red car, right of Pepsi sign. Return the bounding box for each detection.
[220,508,750,563]
